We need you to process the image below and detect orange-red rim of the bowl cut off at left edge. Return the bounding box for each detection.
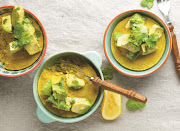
[0,5,47,77]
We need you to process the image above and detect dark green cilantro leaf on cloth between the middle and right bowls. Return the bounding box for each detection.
[102,65,116,80]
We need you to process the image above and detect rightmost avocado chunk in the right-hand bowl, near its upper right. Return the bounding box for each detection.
[149,24,164,38]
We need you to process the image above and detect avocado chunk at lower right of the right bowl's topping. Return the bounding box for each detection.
[141,43,158,55]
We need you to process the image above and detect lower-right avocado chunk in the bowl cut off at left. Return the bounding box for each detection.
[24,35,42,55]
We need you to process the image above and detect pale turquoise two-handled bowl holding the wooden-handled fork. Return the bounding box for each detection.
[33,51,104,123]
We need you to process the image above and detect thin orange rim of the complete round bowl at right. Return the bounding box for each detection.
[103,9,172,77]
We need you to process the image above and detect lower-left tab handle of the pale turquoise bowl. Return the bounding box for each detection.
[36,107,55,123]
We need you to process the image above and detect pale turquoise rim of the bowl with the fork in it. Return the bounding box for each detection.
[33,51,104,123]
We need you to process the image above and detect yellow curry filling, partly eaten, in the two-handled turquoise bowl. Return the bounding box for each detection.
[38,61,99,118]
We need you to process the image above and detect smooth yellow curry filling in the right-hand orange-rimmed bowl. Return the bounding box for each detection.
[111,16,166,71]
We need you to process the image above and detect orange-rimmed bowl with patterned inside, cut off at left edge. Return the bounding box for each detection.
[0,6,47,77]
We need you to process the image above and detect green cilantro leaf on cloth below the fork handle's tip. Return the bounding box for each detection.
[126,100,145,111]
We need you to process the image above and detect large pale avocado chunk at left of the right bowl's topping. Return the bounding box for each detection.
[116,34,140,53]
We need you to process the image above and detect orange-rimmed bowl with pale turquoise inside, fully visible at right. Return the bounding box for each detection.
[103,9,172,77]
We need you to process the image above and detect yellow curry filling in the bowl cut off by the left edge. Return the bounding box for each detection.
[0,12,43,70]
